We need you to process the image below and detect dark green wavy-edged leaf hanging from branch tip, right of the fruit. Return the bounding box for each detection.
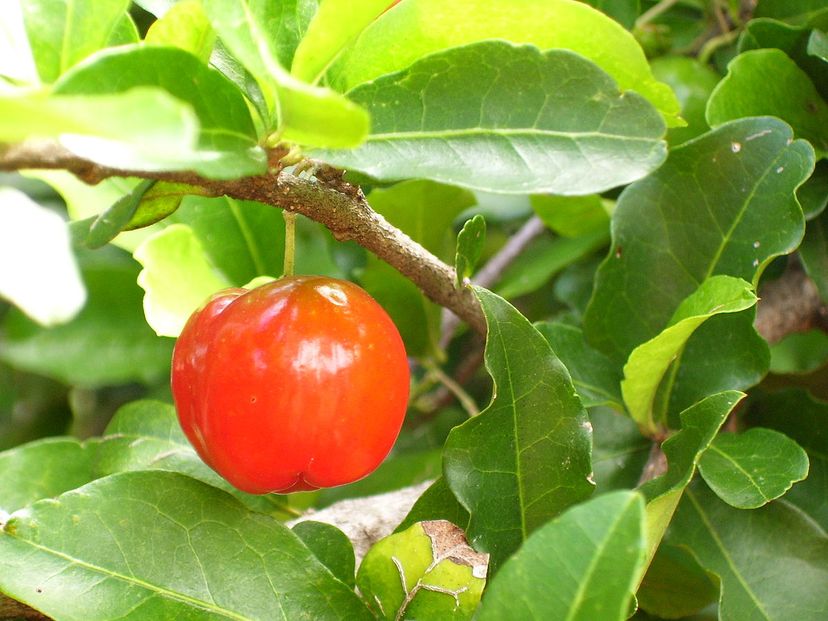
[443,288,593,570]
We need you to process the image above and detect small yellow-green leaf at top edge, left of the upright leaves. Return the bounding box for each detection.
[144,0,216,62]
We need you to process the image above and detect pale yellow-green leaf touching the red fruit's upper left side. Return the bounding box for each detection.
[134,224,232,337]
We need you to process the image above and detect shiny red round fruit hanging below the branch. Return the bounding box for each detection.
[172,276,409,494]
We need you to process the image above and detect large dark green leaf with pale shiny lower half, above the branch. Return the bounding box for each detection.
[315,41,665,194]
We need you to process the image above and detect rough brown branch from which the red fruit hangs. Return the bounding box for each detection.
[0,140,486,334]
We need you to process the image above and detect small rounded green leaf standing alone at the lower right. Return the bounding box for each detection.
[699,427,808,509]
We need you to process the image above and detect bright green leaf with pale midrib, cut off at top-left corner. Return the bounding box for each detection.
[21,0,129,83]
